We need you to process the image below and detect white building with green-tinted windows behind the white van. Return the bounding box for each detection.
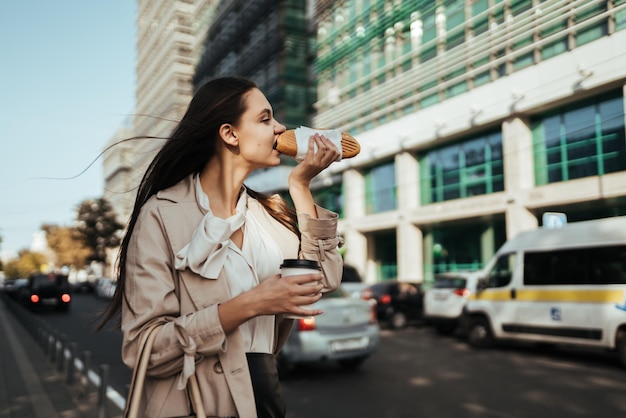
[313,0,626,281]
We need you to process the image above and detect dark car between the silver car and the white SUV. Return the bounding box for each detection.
[361,280,424,329]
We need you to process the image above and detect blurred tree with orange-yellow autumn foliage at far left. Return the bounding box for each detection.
[41,225,91,269]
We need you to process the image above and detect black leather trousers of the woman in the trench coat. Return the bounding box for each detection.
[246,353,286,418]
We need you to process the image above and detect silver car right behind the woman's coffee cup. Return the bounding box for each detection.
[278,288,380,376]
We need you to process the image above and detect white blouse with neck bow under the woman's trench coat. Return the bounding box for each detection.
[176,175,283,353]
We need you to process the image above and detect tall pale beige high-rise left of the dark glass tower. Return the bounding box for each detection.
[104,0,219,223]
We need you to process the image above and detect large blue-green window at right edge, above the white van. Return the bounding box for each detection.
[532,92,626,185]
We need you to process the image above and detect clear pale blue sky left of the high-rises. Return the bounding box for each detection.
[0,0,137,259]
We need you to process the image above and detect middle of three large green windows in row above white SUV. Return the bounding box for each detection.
[420,132,504,204]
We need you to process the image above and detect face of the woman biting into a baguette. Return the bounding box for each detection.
[233,89,285,169]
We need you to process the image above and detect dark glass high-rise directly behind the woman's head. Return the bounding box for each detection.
[194,0,315,195]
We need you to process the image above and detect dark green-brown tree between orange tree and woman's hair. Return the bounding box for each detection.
[75,198,123,263]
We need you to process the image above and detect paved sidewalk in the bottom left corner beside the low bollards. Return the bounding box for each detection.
[0,299,121,418]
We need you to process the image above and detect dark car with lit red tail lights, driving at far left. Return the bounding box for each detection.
[19,273,72,311]
